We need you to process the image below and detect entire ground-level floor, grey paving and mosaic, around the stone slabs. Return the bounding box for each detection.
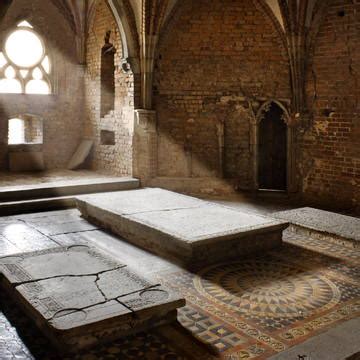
[0,211,360,360]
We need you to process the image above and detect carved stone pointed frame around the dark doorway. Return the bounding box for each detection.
[250,99,297,194]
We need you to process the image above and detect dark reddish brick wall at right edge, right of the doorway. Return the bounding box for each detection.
[300,0,360,208]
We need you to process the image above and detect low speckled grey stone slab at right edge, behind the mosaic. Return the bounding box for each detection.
[272,207,360,245]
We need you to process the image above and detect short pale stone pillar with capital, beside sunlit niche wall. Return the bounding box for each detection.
[133,109,157,185]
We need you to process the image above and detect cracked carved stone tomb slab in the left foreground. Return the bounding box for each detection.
[0,245,185,352]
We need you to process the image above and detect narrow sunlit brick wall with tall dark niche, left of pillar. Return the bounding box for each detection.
[85,0,139,176]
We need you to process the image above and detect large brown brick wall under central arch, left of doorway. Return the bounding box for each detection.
[154,0,290,188]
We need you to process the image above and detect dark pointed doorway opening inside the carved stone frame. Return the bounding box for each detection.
[257,102,288,191]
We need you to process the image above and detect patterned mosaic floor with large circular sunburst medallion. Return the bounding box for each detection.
[161,233,360,359]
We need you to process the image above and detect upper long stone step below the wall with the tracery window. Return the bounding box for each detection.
[0,177,140,202]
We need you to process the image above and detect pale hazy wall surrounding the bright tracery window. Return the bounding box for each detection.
[0,0,84,170]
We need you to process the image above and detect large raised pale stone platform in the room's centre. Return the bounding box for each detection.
[77,188,288,264]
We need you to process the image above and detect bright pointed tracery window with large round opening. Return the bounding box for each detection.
[0,21,51,95]
